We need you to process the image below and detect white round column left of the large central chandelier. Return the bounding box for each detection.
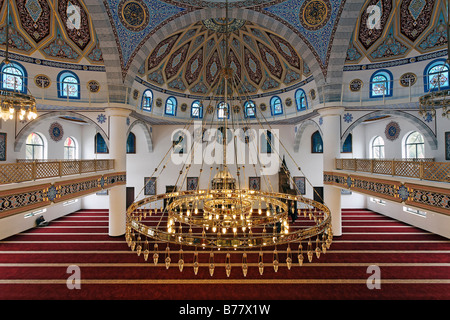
[106,108,130,237]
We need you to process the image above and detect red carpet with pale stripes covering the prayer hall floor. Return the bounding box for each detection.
[0,210,450,300]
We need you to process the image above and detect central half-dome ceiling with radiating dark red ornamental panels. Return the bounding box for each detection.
[144,19,305,94]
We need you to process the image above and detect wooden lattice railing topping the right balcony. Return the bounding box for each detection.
[335,158,450,182]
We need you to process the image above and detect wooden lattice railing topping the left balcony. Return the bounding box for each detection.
[0,159,114,185]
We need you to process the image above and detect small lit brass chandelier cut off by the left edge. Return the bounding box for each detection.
[0,1,37,121]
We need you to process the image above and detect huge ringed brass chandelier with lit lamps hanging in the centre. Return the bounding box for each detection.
[125,2,333,277]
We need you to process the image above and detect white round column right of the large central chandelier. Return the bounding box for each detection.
[318,107,344,236]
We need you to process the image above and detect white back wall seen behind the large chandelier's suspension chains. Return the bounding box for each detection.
[121,126,323,198]
